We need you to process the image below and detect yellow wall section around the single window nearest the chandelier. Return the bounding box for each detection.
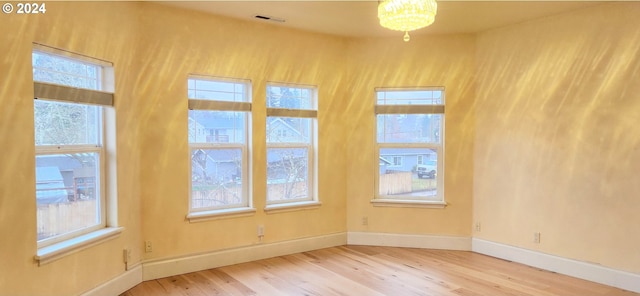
[345,34,475,236]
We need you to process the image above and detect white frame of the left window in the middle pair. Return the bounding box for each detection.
[187,75,255,222]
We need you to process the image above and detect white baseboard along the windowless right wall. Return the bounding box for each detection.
[472,238,640,293]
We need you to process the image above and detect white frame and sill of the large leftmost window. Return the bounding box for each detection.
[33,44,122,265]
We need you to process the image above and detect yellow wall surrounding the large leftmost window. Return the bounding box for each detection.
[0,2,141,295]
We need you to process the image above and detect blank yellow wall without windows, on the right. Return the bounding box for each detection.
[473,2,640,272]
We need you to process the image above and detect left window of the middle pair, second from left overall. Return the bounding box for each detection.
[187,77,251,213]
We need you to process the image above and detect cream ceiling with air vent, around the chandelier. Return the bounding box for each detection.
[162,0,602,38]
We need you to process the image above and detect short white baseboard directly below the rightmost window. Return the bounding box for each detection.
[347,232,471,251]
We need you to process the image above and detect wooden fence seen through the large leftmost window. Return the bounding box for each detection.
[36,199,100,240]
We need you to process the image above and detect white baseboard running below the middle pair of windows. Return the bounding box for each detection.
[142,232,347,281]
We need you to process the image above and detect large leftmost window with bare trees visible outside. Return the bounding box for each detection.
[32,50,113,247]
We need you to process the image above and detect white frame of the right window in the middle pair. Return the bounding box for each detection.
[265,82,320,211]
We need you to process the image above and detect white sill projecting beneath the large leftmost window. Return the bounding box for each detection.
[34,227,124,266]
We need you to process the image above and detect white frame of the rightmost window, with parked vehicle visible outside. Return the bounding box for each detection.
[371,87,446,208]
